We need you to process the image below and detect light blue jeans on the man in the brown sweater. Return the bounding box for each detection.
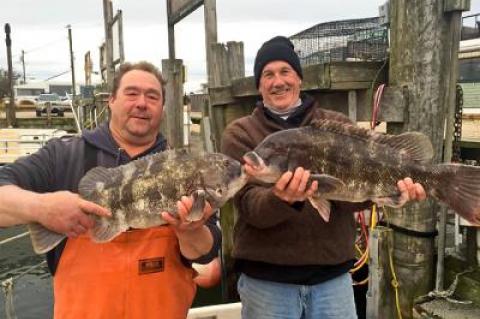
[237,273,357,319]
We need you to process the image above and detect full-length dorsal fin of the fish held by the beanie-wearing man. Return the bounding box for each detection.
[312,120,433,163]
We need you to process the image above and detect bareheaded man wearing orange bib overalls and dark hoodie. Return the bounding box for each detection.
[0,62,221,319]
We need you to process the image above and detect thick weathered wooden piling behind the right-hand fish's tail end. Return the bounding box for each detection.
[387,0,460,318]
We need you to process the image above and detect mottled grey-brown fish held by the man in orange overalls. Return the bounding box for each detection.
[29,150,246,253]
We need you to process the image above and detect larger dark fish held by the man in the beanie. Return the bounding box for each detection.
[245,120,480,224]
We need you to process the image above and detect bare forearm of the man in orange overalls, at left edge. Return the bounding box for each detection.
[0,185,41,227]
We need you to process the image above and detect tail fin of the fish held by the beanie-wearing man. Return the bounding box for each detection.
[431,164,480,226]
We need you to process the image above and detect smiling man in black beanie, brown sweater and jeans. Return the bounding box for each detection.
[222,36,426,319]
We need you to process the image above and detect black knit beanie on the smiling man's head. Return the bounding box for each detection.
[253,36,303,89]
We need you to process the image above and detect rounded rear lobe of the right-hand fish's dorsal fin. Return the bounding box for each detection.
[373,132,433,163]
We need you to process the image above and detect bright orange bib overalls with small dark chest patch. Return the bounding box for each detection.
[54,226,196,319]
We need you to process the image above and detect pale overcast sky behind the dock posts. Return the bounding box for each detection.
[0,0,480,92]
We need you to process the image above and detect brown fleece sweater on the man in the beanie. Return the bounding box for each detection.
[222,98,367,268]
